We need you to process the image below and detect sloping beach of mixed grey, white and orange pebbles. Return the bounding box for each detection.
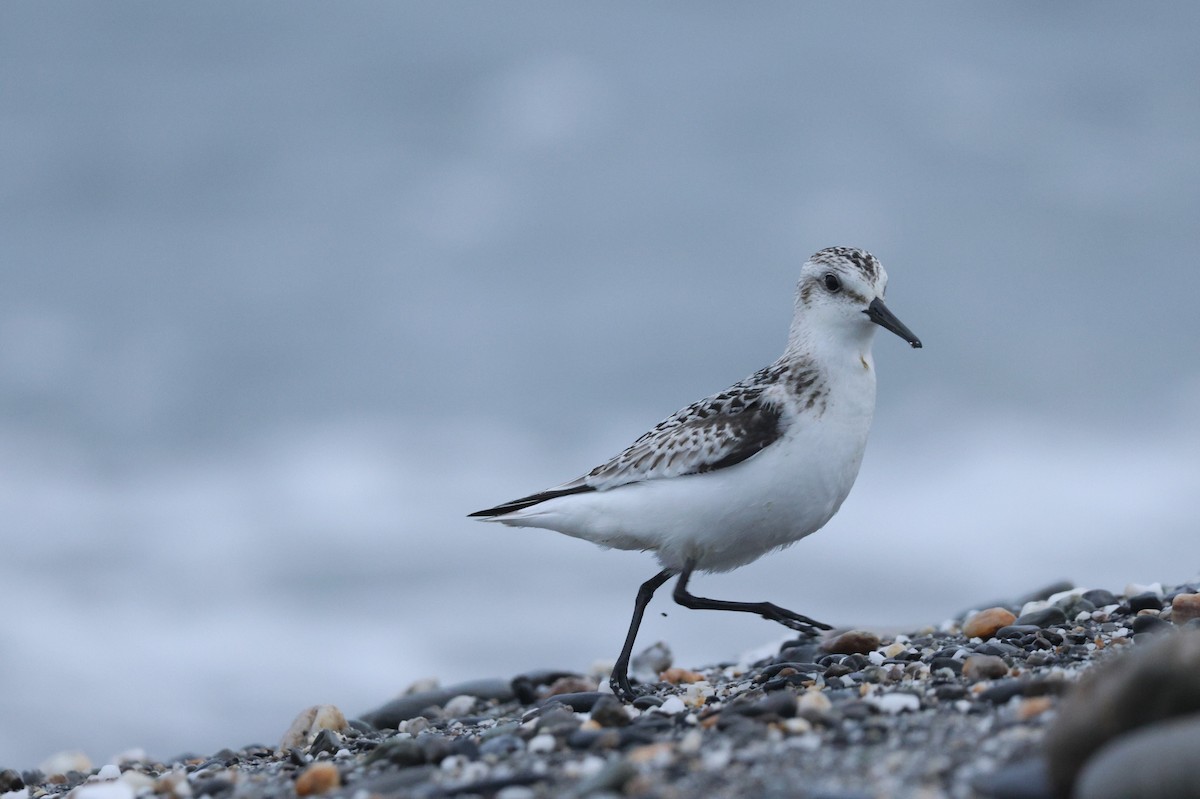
[9,582,1200,799]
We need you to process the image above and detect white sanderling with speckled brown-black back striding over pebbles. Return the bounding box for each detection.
[470,247,920,701]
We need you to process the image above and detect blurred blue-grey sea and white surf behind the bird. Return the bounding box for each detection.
[0,0,1200,768]
